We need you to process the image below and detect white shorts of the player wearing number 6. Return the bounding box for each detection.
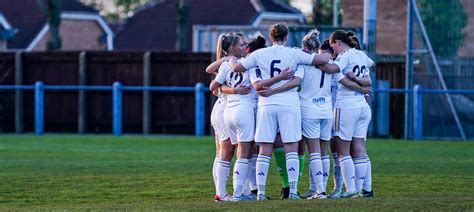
[255,105,301,143]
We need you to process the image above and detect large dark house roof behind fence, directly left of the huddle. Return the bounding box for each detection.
[115,0,301,50]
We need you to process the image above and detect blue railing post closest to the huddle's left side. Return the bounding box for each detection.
[194,82,205,136]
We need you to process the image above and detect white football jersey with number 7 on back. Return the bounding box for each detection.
[298,55,333,119]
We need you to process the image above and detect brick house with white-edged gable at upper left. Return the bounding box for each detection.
[0,0,113,51]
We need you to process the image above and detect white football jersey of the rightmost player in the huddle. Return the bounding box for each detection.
[331,48,373,109]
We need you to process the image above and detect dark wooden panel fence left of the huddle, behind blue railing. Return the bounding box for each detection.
[0,52,211,134]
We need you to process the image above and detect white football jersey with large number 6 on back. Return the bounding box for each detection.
[240,45,313,107]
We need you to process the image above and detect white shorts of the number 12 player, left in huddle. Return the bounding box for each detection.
[224,104,256,144]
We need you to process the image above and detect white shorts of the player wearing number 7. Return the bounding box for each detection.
[301,118,332,141]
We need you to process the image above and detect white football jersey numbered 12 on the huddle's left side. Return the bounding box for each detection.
[214,61,257,107]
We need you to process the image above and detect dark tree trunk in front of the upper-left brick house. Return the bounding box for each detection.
[36,0,61,50]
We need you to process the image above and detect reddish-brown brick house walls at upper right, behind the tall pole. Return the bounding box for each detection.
[341,0,474,57]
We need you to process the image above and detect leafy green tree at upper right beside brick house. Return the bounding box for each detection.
[419,0,467,57]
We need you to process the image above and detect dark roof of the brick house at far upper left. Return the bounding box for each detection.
[0,0,98,49]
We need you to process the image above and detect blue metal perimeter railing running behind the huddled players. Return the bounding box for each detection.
[0,81,474,140]
